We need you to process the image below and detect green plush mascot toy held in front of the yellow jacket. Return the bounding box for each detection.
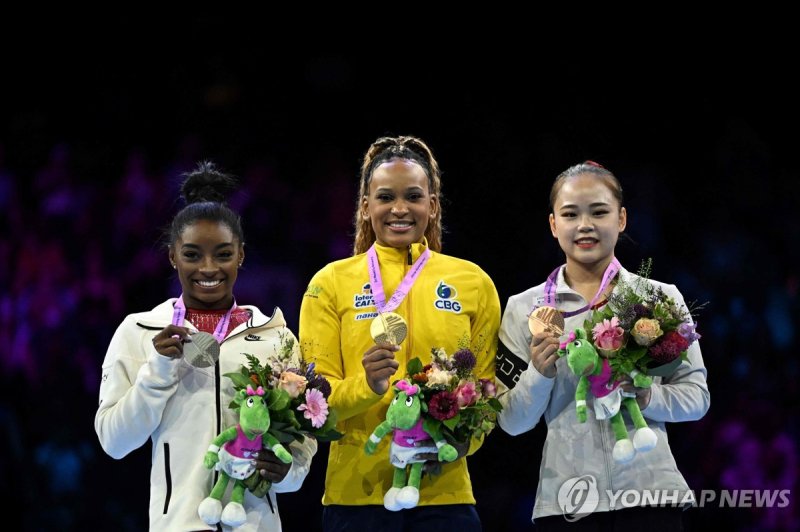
[364,380,458,512]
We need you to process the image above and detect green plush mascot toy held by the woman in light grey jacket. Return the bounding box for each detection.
[558,329,658,463]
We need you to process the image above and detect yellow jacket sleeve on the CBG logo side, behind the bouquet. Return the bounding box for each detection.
[467,272,500,456]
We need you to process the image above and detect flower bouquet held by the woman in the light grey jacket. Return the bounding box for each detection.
[583,259,702,376]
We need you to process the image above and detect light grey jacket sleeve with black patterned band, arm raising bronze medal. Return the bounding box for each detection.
[497,294,555,436]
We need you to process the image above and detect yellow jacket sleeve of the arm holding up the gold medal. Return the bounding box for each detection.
[300,264,382,421]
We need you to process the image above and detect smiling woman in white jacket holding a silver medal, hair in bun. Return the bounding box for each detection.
[95,162,317,531]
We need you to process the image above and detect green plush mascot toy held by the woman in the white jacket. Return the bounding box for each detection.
[197,385,292,527]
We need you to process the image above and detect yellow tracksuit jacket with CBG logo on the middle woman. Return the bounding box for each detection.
[299,244,500,505]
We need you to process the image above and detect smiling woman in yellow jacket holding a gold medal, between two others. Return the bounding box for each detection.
[300,137,500,532]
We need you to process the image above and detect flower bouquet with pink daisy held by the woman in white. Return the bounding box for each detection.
[225,337,343,497]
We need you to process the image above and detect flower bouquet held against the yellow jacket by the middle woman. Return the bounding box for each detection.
[406,347,502,443]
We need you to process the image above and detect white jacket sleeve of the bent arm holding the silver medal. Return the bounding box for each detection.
[94,317,179,458]
